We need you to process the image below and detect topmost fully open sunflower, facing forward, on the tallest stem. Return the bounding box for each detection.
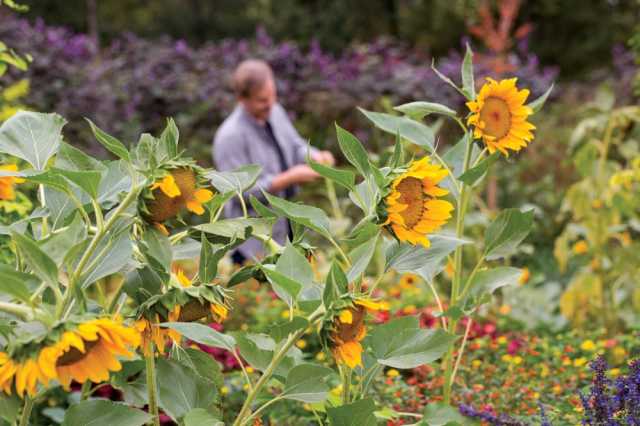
[467,78,535,155]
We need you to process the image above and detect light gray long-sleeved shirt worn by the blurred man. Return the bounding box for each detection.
[213,104,315,259]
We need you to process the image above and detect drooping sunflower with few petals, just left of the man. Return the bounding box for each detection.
[147,167,213,223]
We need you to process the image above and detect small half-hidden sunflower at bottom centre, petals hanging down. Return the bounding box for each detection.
[329,299,387,368]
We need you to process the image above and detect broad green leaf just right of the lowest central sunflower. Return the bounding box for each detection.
[368,317,456,369]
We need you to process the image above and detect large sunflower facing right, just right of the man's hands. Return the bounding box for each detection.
[385,157,453,247]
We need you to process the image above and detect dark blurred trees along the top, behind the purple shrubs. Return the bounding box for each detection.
[24,0,640,78]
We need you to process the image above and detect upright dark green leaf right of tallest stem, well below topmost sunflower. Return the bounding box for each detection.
[484,209,533,260]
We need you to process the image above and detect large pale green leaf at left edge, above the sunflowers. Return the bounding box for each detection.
[0,111,66,170]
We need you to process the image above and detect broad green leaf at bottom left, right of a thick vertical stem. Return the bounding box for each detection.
[156,358,218,422]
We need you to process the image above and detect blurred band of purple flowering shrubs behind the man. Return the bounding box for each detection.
[0,16,556,163]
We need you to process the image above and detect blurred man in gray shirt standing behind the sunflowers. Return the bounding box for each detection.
[213,59,334,263]
